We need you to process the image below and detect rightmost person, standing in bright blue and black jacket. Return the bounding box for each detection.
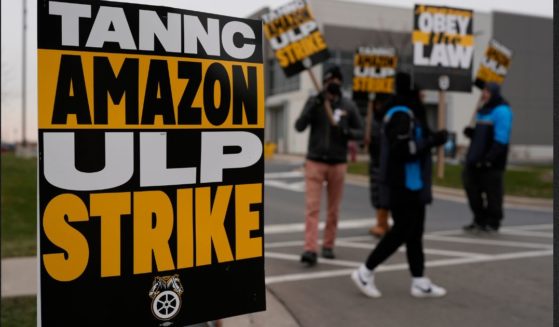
[462,83,513,232]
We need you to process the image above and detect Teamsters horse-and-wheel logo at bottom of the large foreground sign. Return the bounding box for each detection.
[149,275,184,320]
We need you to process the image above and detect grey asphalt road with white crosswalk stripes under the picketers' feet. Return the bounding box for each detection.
[264,158,553,327]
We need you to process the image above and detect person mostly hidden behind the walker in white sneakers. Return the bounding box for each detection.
[363,94,390,238]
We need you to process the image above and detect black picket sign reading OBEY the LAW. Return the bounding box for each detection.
[412,5,474,92]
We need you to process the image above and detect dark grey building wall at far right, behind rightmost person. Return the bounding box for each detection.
[493,12,553,147]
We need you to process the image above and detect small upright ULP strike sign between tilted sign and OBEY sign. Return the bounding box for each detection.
[353,47,398,100]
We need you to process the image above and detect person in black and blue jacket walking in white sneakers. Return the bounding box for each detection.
[351,73,448,297]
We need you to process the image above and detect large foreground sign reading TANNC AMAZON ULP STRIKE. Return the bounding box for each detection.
[37,0,266,327]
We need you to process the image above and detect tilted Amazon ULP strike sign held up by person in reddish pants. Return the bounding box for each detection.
[262,0,330,77]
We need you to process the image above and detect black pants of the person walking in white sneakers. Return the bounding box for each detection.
[365,190,425,277]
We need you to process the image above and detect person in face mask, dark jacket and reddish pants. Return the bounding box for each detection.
[295,66,363,266]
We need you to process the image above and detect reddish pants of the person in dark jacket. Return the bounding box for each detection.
[305,160,347,252]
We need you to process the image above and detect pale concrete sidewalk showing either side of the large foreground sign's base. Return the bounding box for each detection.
[2,257,299,327]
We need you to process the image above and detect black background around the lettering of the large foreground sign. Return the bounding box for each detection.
[37,0,266,327]
